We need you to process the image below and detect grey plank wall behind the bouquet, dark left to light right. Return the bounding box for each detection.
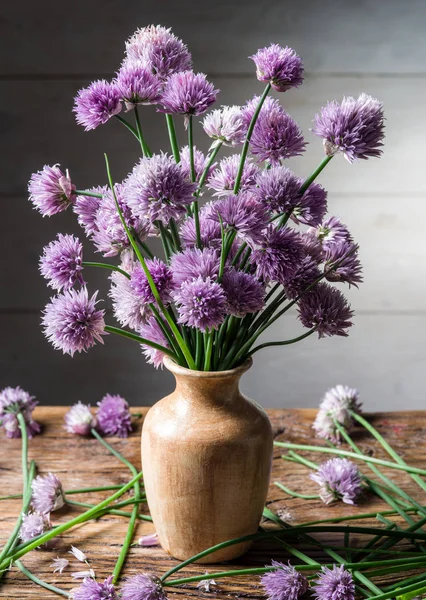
[0,0,426,409]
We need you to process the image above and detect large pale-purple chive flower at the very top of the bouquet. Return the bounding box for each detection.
[124,25,192,80]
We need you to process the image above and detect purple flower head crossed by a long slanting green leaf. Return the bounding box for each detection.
[130,258,173,304]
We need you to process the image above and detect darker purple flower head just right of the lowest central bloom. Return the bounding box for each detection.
[222,269,265,317]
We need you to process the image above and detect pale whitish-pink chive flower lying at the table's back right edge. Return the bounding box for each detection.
[312,385,361,444]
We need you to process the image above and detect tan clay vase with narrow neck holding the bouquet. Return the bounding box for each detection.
[142,358,272,563]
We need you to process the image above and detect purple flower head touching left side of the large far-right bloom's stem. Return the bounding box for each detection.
[255,165,301,214]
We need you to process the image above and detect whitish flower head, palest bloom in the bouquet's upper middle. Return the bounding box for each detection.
[202,106,247,146]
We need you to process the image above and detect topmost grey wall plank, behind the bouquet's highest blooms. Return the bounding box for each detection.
[0,0,426,75]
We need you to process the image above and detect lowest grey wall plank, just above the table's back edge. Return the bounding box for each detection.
[0,313,426,410]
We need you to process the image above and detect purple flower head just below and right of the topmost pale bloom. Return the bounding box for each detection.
[158,71,219,118]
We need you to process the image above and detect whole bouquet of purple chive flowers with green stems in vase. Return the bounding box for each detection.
[29,26,384,371]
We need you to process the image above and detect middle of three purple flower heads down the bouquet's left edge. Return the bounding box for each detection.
[40,233,85,292]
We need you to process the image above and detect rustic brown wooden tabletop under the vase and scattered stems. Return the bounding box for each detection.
[0,407,426,600]
